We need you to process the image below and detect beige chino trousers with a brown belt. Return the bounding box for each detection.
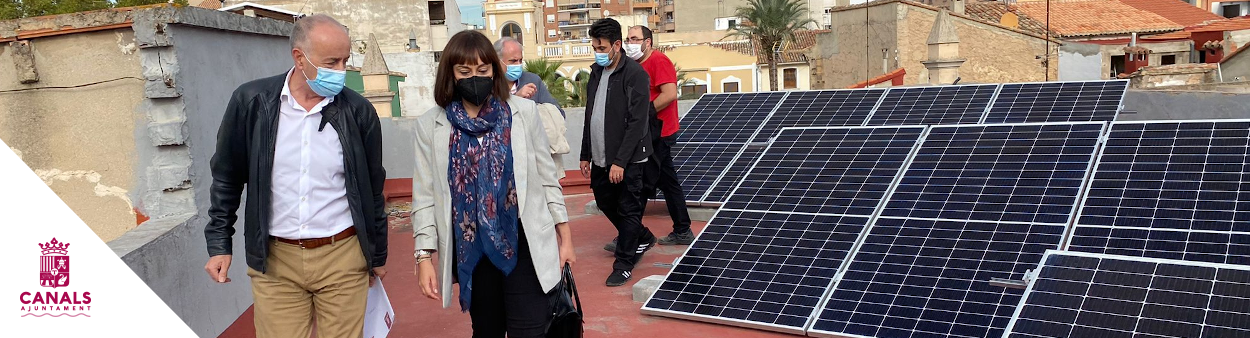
[248,237,369,338]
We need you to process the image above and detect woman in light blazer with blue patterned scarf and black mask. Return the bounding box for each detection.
[413,30,576,338]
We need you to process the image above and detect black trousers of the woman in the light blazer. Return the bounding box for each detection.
[467,223,551,338]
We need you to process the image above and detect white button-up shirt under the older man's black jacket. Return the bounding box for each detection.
[269,69,353,239]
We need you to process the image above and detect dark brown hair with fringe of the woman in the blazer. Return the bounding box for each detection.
[434,30,510,108]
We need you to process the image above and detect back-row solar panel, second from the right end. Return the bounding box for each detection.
[865,84,999,125]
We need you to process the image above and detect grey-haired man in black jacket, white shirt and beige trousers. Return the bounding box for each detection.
[204,15,388,338]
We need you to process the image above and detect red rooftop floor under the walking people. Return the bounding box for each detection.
[219,190,780,338]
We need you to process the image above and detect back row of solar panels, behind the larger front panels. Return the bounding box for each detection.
[674,80,1128,203]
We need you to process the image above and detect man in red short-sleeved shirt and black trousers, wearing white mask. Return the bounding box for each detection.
[625,26,695,245]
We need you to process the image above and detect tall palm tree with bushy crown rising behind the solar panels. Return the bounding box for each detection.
[729,0,816,90]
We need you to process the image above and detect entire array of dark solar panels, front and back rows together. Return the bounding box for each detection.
[644,81,1250,338]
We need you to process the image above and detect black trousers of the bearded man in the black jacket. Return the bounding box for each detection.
[590,163,655,270]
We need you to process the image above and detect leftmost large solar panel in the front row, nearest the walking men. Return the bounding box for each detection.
[643,126,925,333]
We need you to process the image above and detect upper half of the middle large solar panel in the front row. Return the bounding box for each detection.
[881,123,1104,224]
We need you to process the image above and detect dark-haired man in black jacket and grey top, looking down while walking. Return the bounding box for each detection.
[581,19,656,287]
